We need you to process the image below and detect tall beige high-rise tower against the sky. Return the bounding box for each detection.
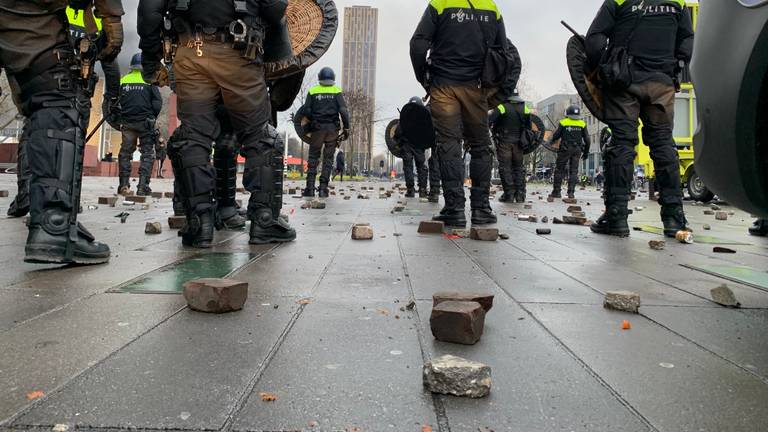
[342,6,379,172]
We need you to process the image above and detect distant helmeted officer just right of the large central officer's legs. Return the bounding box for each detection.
[488,93,531,203]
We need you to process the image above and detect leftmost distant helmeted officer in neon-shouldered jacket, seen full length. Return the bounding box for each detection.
[117,54,163,196]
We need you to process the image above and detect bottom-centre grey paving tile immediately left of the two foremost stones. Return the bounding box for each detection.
[234,301,436,431]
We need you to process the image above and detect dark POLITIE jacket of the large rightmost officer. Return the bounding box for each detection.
[587,0,696,82]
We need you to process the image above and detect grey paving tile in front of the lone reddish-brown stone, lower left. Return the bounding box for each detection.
[14,300,298,429]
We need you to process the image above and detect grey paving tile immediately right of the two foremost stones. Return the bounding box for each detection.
[418,297,649,432]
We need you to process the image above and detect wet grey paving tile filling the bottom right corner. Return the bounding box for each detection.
[529,305,768,432]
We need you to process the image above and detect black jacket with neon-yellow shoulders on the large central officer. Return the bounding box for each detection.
[411,0,507,87]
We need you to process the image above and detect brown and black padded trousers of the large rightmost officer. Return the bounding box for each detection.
[604,81,683,206]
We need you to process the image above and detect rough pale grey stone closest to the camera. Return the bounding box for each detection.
[423,355,492,398]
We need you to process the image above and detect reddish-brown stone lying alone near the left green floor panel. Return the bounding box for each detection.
[184,279,248,314]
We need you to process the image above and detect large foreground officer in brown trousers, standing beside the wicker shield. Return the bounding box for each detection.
[138,0,296,248]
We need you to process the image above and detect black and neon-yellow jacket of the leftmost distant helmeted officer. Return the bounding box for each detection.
[120,70,163,125]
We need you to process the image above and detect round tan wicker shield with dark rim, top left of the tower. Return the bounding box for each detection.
[266,0,339,80]
